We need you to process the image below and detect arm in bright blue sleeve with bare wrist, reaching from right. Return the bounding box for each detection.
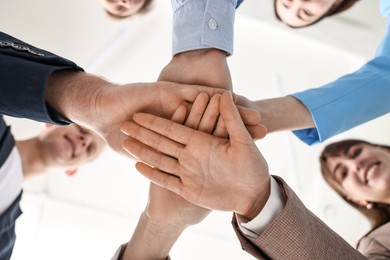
[238,56,390,144]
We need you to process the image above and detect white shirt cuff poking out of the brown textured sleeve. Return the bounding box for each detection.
[236,177,285,238]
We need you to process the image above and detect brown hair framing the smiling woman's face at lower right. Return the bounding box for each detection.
[320,139,390,245]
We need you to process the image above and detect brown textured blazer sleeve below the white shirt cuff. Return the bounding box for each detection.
[232,176,366,260]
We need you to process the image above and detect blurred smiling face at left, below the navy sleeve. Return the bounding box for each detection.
[39,124,105,167]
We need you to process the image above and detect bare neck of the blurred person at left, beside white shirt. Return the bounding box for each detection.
[16,137,49,179]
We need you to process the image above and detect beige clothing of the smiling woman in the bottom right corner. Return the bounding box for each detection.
[358,222,390,259]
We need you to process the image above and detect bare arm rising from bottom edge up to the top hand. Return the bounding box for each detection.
[120,184,210,260]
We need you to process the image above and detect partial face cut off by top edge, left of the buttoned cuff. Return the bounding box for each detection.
[98,0,145,17]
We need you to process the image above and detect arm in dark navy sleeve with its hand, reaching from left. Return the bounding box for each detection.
[0,33,232,156]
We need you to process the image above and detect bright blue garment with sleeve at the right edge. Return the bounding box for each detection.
[291,0,390,144]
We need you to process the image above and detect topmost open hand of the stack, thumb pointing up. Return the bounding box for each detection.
[122,93,270,219]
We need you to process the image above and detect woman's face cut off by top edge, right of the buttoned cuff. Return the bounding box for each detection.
[275,0,342,27]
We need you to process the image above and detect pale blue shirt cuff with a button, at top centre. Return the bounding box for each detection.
[171,0,237,55]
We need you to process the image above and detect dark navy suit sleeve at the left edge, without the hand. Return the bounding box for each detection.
[0,32,83,124]
